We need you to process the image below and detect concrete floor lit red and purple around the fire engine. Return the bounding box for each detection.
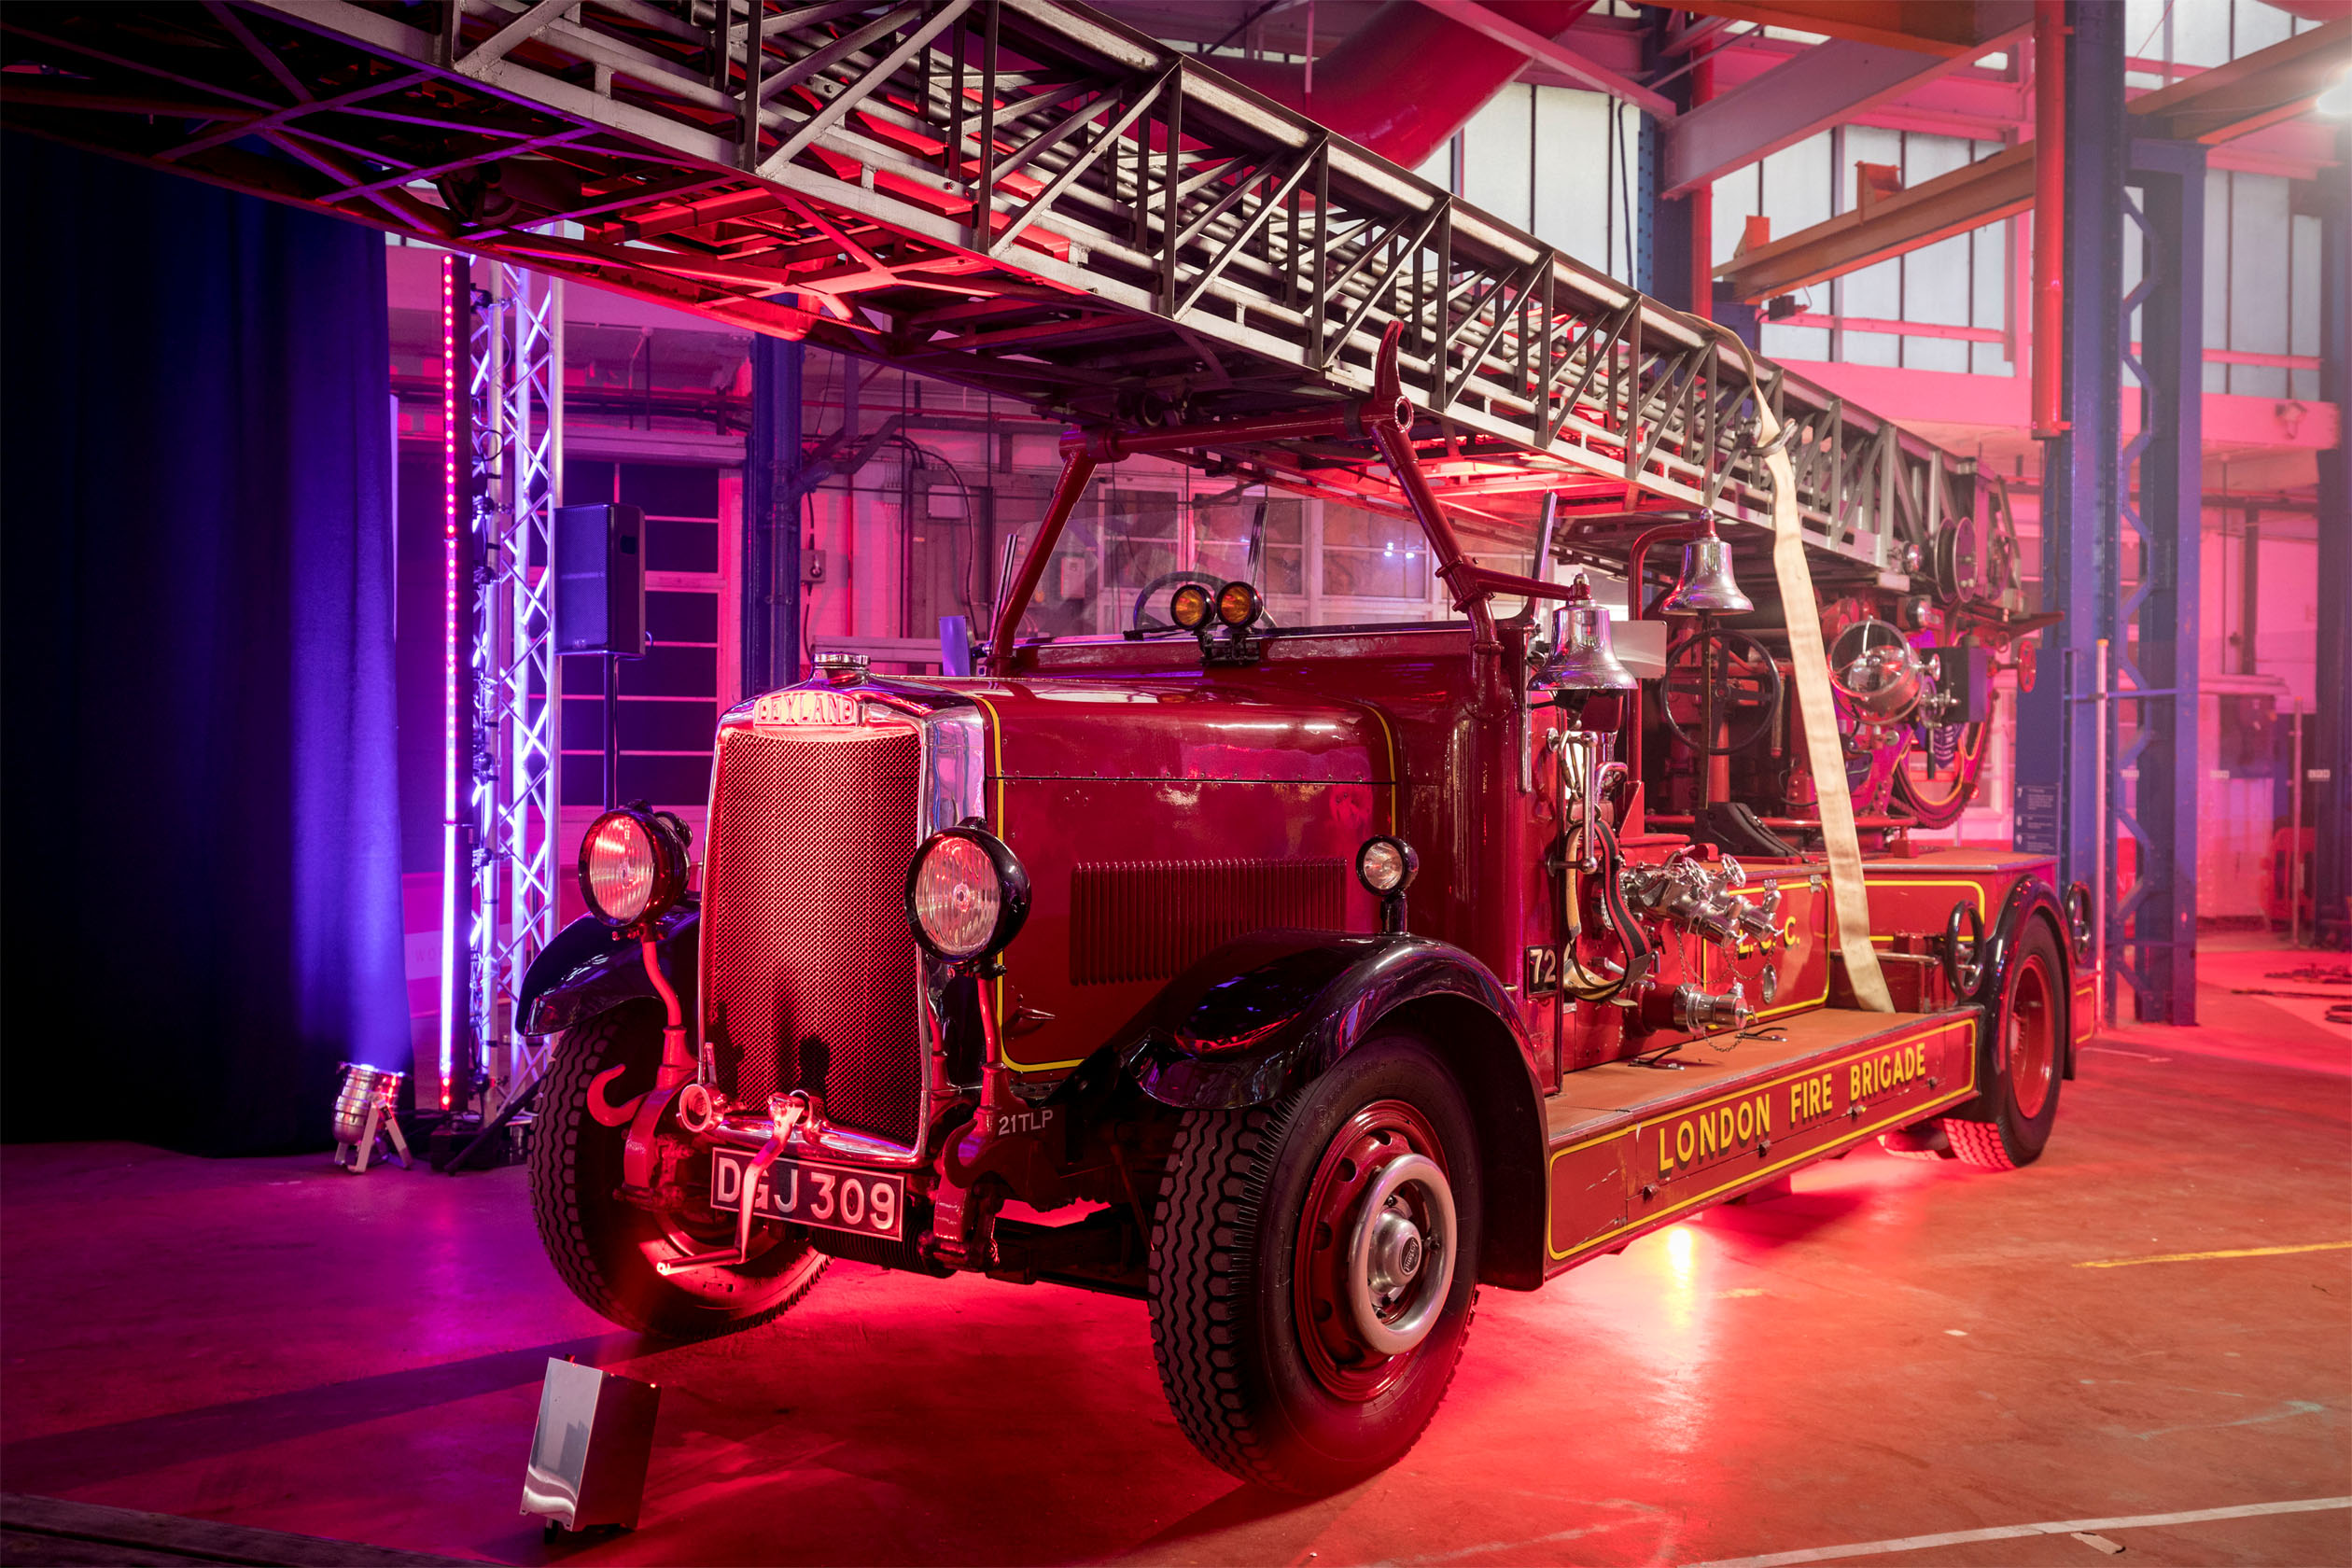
[0,943,2352,1568]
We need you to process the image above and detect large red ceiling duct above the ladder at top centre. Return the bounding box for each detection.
[1213,0,1592,169]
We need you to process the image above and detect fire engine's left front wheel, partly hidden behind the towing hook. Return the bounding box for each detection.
[532,1004,828,1340]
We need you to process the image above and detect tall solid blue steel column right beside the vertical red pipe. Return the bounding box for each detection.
[2013,0,2129,968]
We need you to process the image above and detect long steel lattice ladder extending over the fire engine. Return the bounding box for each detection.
[0,0,1978,576]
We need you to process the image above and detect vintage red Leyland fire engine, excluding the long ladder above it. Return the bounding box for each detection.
[522,324,2091,1491]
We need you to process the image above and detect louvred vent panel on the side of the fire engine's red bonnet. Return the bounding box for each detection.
[1071,861,1348,985]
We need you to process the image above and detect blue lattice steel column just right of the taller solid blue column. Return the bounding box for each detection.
[2107,141,2206,1025]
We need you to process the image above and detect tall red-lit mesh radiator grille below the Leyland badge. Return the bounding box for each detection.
[703,726,924,1147]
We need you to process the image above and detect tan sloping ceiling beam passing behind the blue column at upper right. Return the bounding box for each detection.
[1715,17,2352,301]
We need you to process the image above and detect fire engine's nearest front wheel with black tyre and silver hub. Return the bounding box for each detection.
[1148,1034,1482,1492]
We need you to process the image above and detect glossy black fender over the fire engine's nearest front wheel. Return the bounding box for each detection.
[1113,931,1526,1110]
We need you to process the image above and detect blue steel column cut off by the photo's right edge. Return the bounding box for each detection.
[2303,124,2352,947]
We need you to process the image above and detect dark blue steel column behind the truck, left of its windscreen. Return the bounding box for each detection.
[738,336,809,696]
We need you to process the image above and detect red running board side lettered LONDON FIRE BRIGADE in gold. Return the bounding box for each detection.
[1546,1009,1981,1274]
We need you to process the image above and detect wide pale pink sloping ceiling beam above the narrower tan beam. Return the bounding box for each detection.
[1660,33,2009,195]
